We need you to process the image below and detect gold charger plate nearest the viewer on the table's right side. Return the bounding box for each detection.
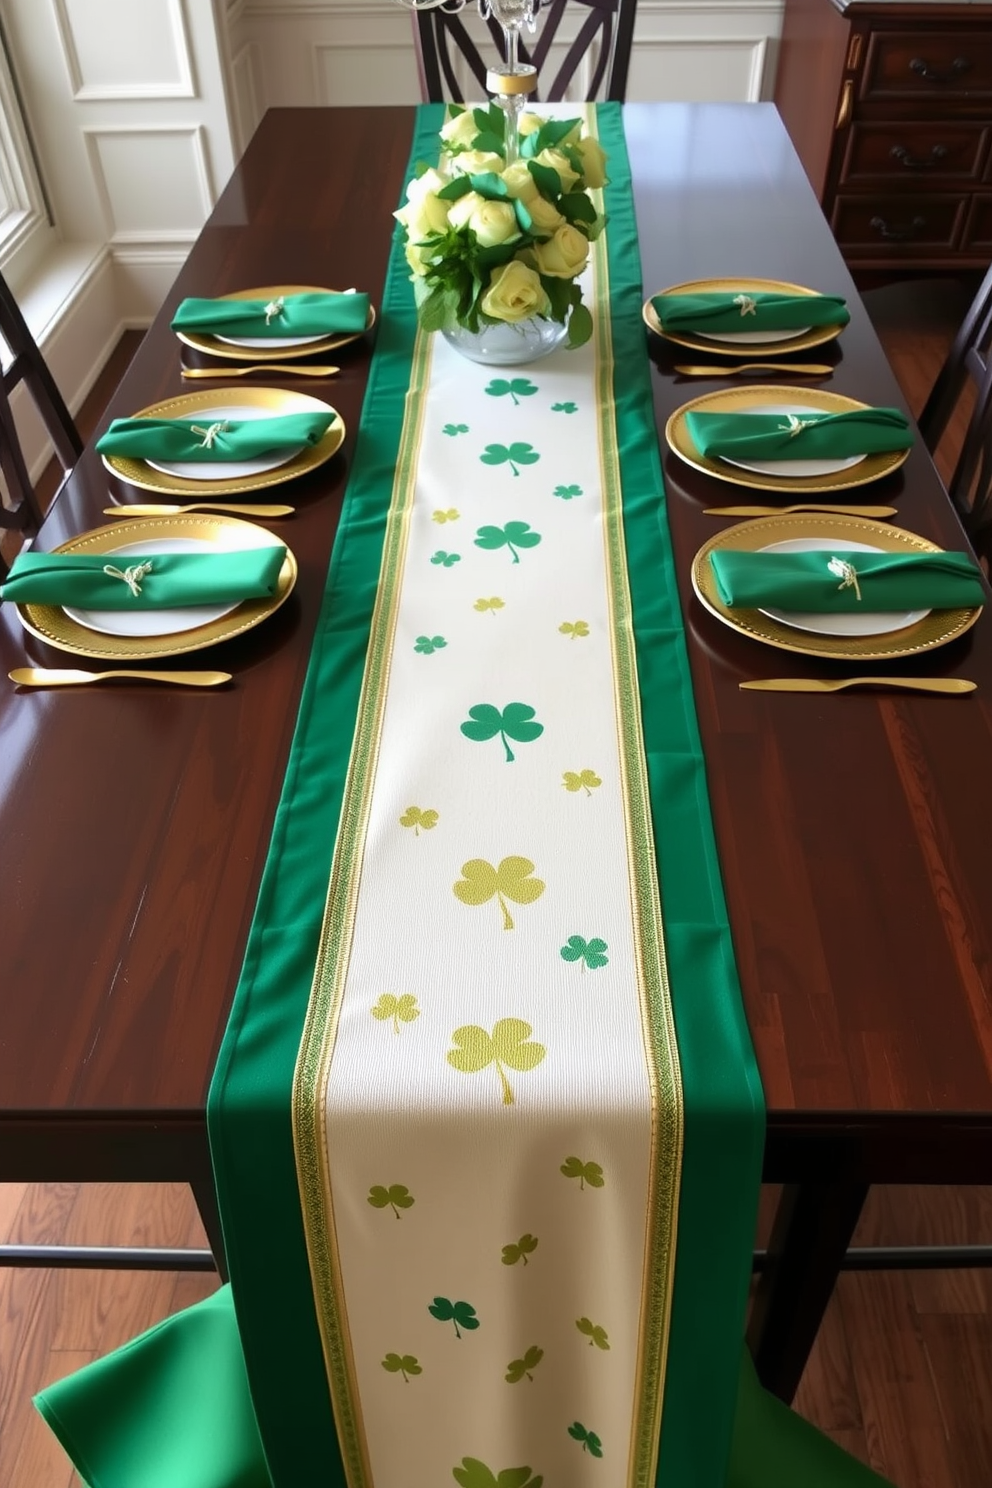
[692,513,982,661]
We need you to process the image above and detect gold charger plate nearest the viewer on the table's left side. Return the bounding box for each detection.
[16,512,296,661]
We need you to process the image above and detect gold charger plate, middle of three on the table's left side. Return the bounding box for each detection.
[101,387,345,497]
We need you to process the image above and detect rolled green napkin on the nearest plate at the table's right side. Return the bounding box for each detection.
[709,548,985,615]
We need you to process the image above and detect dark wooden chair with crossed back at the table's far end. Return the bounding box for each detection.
[412,0,637,103]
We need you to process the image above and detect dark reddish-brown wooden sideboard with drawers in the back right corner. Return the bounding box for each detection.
[775,0,992,271]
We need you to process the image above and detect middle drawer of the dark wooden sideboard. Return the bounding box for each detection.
[840,124,989,182]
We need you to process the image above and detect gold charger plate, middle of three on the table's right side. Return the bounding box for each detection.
[665,384,909,493]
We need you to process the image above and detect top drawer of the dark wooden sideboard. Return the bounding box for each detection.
[861,31,992,100]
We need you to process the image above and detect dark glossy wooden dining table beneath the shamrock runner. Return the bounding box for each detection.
[0,103,992,1434]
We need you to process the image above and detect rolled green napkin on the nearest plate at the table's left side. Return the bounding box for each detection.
[0,543,286,610]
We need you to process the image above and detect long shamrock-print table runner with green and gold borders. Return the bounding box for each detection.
[210,106,763,1488]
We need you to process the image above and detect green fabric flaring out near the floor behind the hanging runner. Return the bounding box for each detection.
[34,1287,892,1488]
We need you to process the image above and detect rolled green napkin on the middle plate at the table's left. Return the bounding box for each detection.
[97,411,338,464]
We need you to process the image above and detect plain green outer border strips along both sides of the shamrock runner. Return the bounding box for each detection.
[207,104,764,1488]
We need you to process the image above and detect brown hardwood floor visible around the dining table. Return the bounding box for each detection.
[0,283,992,1488]
